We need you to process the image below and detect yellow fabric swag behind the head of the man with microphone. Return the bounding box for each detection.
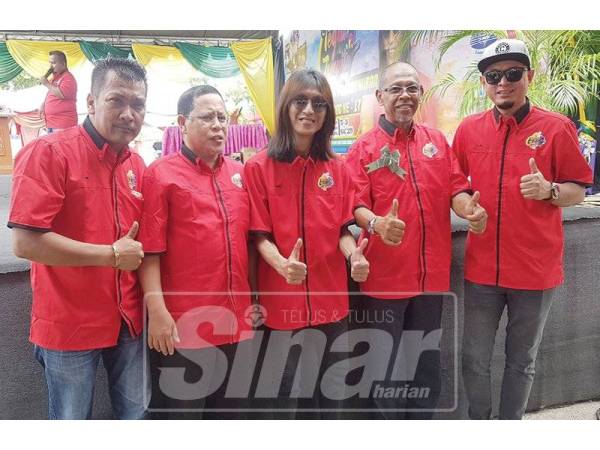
[6,39,87,78]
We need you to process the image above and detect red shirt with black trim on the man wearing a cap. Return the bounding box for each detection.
[452,103,592,290]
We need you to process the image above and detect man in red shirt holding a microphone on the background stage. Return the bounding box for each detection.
[40,50,77,133]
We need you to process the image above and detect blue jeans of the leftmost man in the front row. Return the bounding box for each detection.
[34,324,150,419]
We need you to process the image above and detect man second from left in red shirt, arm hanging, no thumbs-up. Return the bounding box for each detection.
[140,86,253,418]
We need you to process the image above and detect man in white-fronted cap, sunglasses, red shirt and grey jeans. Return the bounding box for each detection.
[452,39,592,419]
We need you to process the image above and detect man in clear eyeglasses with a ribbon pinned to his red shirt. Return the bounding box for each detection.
[347,63,487,419]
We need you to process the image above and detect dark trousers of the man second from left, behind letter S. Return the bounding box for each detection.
[150,342,251,420]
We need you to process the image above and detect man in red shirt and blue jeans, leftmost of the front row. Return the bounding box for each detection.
[8,58,147,419]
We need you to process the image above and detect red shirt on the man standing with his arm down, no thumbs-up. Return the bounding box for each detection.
[139,146,253,348]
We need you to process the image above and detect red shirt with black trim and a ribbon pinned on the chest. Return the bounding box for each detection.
[346,115,469,299]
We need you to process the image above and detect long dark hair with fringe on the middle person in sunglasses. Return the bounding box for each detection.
[267,69,335,162]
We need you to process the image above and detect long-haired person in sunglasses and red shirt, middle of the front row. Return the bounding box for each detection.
[244,70,369,417]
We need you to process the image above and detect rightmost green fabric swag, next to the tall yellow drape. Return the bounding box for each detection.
[174,42,240,78]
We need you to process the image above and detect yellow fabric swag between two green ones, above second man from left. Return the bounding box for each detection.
[131,44,198,83]
